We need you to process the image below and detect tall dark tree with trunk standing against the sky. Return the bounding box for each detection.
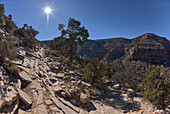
[58,18,89,61]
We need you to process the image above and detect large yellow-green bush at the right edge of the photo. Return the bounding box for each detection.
[142,66,170,109]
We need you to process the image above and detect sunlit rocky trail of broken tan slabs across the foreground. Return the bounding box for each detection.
[0,47,169,114]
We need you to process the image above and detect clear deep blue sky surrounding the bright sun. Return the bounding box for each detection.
[0,0,170,40]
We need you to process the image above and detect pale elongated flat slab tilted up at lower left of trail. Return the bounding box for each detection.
[17,88,32,106]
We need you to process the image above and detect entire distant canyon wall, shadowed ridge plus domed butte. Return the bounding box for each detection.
[77,33,170,66]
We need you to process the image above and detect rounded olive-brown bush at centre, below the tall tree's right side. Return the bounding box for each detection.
[82,59,114,85]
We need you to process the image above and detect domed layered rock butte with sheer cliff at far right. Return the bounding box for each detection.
[125,34,170,66]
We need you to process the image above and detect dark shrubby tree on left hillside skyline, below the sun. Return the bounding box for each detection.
[14,24,39,48]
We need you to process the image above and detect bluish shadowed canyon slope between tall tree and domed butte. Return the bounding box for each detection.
[77,38,131,62]
